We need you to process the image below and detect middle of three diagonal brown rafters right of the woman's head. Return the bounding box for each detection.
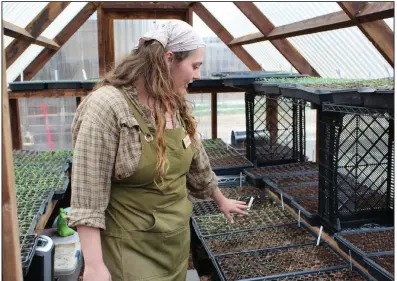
[234,2,320,77]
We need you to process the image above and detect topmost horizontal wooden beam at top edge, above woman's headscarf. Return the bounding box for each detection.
[101,1,189,12]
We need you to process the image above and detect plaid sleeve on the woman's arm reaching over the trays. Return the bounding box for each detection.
[186,146,218,199]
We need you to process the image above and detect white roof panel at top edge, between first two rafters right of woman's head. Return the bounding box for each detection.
[201,2,259,37]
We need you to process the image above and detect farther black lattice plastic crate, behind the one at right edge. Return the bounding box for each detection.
[245,93,306,166]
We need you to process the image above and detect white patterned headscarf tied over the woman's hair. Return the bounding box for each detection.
[134,20,205,52]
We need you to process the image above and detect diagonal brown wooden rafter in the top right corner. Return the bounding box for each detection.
[338,2,394,67]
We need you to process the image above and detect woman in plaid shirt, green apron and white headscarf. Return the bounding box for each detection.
[69,21,247,281]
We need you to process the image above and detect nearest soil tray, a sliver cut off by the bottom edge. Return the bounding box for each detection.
[262,267,374,281]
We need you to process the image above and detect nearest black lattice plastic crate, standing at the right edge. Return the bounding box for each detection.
[318,104,394,231]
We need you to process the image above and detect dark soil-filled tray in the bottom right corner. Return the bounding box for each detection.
[364,252,394,281]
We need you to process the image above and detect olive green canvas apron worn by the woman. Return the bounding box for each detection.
[101,90,193,281]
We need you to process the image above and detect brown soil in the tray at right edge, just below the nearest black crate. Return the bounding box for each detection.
[341,230,394,253]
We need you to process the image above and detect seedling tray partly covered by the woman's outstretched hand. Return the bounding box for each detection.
[192,195,275,217]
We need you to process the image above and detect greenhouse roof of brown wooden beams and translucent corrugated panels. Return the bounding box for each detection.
[2,1,394,82]
